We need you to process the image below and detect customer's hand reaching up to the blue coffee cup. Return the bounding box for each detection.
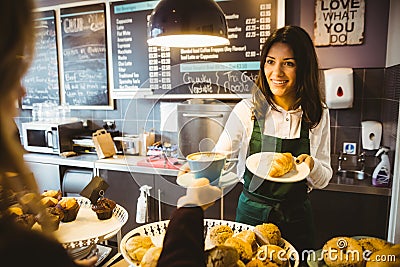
[178,178,221,210]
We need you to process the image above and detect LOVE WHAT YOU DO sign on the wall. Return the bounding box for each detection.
[314,0,365,46]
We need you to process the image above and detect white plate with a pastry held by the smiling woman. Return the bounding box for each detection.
[246,152,310,183]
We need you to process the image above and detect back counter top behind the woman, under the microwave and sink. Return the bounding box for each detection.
[24,153,391,196]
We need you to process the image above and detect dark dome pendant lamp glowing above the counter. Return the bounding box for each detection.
[147,0,229,47]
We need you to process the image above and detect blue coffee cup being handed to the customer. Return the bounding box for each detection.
[186,152,235,185]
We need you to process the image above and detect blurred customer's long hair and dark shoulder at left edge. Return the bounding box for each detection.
[0,0,97,266]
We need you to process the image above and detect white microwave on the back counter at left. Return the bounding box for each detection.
[21,121,84,154]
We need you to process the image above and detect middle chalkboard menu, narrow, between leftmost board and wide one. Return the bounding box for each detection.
[60,3,109,106]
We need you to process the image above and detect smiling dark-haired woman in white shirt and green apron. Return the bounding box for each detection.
[215,26,332,256]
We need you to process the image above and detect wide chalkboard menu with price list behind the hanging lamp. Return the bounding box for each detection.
[110,0,283,95]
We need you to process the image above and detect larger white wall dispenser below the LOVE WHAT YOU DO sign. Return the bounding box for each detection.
[324,68,354,109]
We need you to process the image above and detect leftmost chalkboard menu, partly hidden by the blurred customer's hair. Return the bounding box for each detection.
[22,10,60,108]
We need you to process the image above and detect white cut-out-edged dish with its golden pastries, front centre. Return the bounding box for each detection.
[121,219,299,267]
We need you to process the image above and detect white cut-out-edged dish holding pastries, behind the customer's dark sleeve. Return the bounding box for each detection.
[119,219,299,267]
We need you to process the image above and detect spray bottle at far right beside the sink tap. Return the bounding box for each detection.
[372,147,390,187]
